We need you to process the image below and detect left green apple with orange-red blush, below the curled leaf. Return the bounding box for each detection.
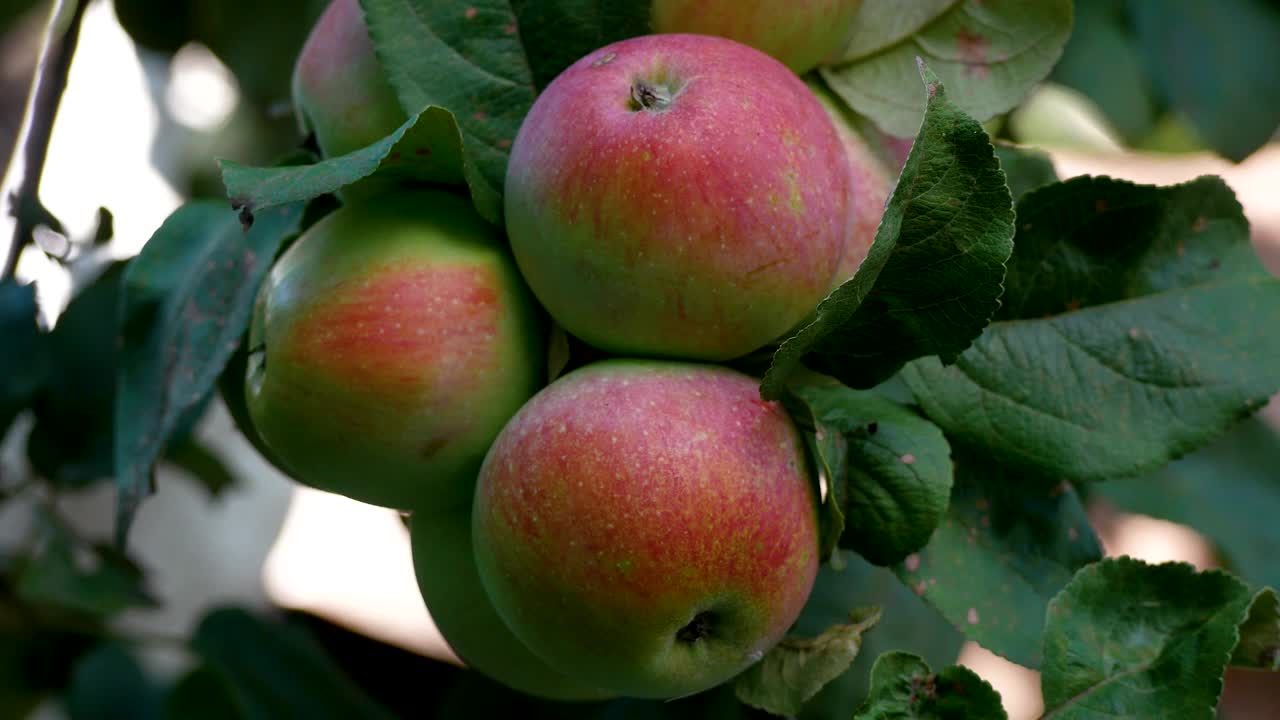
[244,188,545,509]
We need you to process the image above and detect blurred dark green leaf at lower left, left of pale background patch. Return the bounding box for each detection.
[17,515,157,618]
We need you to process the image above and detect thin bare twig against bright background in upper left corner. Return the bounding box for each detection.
[0,0,91,279]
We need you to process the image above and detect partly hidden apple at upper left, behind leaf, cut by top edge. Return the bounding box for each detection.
[293,0,407,158]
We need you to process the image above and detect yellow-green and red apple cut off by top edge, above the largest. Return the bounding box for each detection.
[653,0,861,74]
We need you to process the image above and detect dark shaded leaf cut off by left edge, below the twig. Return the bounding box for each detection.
[0,279,49,439]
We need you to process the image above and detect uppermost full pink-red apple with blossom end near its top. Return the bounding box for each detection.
[504,35,854,360]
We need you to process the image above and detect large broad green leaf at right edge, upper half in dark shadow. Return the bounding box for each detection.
[902,178,1280,480]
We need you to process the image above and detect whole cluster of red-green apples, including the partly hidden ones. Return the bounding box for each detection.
[246,0,890,700]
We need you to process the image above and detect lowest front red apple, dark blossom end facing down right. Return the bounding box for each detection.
[472,360,818,698]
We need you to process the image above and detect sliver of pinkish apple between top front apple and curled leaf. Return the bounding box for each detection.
[809,82,910,290]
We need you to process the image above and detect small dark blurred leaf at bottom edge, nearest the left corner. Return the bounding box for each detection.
[67,642,163,720]
